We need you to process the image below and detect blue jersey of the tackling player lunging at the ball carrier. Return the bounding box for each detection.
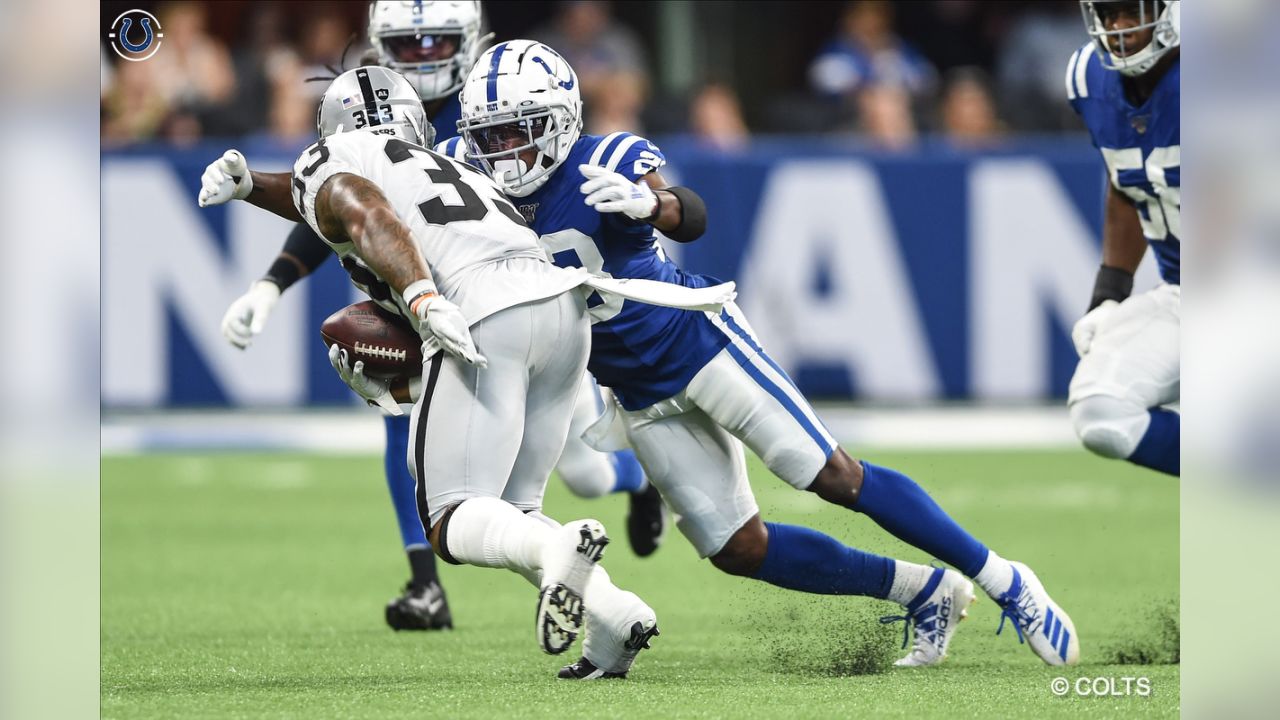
[438,132,728,410]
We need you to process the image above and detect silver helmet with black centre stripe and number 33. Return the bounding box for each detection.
[316,65,435,147]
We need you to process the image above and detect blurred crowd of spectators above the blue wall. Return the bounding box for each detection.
[101,0,1087,150]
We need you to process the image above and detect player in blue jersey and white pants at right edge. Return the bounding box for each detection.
[1066,0,1183,475]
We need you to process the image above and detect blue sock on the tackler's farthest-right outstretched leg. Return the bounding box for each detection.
[856,460,987,578]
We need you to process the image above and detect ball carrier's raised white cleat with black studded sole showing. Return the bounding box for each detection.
[535,520,609,655]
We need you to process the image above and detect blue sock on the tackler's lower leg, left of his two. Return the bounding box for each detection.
[754,523,893,598]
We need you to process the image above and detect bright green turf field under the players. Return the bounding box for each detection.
[102,451,1179,720]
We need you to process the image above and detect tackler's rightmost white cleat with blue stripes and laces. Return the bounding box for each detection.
[995,562,1080,665]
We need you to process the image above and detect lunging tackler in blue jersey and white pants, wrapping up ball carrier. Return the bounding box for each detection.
[450,40,1079,678]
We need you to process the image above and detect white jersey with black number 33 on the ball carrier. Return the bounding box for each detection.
[293,129,581,323]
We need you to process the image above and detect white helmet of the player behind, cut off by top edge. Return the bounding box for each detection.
[369,0,481,101]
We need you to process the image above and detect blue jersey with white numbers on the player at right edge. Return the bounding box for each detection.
[1066,42,1183,284]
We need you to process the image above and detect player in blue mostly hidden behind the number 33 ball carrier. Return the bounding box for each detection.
[201,1,664,630]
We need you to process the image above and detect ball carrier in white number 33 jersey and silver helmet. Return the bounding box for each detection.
[281,68,657,674]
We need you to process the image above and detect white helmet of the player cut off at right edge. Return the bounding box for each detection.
[1080,0,1181,77]
